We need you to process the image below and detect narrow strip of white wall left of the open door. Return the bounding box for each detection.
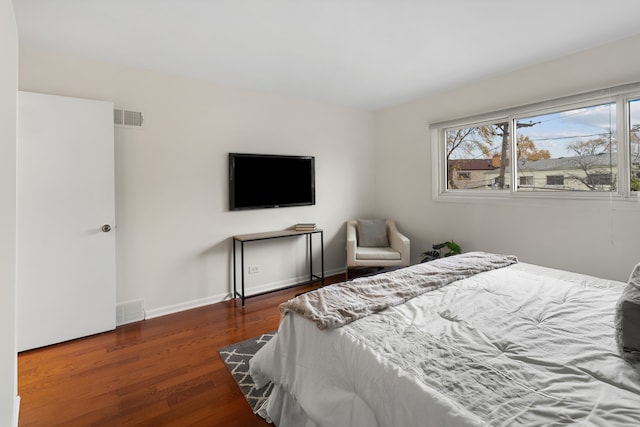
[0,0,18,426]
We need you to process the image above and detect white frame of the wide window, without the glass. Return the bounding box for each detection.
[430,83,640,202]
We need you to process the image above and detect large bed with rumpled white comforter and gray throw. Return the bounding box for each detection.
[250,253,640,427]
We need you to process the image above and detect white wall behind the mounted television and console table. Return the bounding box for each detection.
[20,49,374,316]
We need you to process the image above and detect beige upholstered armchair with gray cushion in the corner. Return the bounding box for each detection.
[347,219,410,277]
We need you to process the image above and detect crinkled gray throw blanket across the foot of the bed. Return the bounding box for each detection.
[280,252,518,329]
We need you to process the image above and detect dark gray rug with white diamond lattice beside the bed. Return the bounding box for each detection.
[218,332,276,413]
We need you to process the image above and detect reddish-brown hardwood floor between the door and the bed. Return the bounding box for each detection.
[18,275,343,427]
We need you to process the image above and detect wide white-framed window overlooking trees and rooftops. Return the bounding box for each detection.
[432,83,640,198]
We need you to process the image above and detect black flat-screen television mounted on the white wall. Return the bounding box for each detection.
[229,153,316,210]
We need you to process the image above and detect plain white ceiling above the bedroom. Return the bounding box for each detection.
[13,0,640,110]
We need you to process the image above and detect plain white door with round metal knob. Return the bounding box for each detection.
[16,92,116,351]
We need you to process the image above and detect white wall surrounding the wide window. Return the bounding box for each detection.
[375,31,640,281]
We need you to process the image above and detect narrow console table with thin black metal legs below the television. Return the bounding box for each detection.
[232,229,324,306]
